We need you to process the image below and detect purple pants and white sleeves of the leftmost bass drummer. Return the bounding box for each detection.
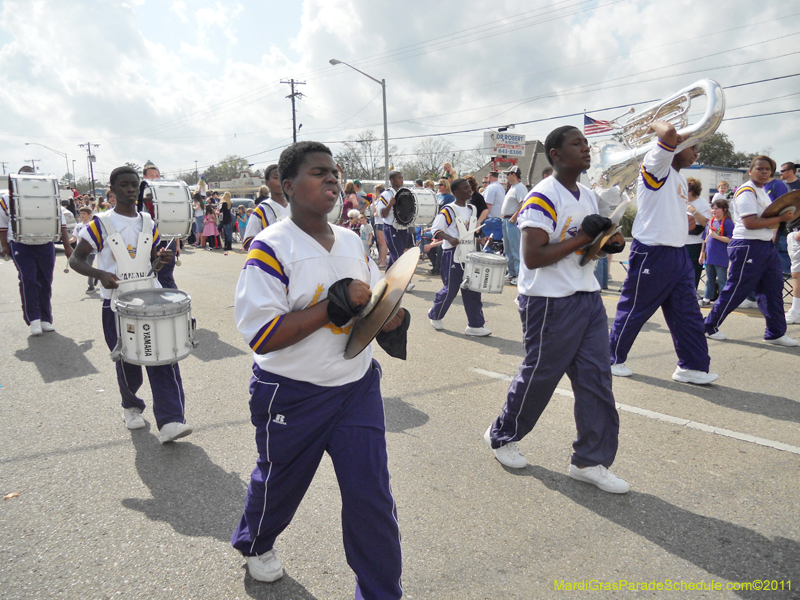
[0,194,67,325]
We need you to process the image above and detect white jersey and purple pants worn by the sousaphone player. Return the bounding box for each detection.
[610,140,711,373]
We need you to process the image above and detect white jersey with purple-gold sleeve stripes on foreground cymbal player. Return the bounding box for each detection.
[233,219,381,387]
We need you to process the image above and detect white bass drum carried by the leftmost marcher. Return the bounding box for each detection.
[8,173,61,244]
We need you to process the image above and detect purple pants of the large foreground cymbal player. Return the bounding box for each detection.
[231,360,402,599]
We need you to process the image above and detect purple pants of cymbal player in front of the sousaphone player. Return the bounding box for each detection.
[491,292,619,467]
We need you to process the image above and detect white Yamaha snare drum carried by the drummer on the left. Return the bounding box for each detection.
[111,288,197,367]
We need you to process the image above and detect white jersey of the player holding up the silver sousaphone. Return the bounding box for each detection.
[633,140,689,248]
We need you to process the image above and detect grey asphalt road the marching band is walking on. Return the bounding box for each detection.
[0,244,800,600]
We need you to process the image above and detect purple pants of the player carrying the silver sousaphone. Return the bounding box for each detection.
[610,240,711,373]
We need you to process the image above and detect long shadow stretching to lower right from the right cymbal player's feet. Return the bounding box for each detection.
[507,465,800,599]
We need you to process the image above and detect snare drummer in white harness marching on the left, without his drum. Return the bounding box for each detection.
[69,167,192,444]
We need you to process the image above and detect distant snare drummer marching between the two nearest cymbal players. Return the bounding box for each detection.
[428,179,492,337]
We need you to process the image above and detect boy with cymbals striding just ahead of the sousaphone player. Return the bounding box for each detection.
[484,126,630,494]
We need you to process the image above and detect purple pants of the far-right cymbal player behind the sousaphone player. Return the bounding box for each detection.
[705,240,786,340]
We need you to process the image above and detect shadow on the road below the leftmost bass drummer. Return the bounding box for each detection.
[14,330,98,383]
